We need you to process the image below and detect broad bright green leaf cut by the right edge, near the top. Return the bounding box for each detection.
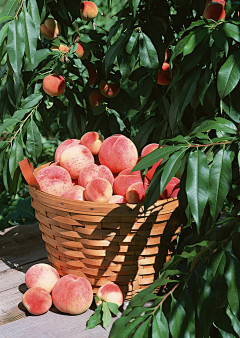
[217,50,240,99]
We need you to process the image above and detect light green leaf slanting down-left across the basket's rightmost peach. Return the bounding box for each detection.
[160,148,186,194]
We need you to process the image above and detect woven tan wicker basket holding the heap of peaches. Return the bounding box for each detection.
[20,160,181,300]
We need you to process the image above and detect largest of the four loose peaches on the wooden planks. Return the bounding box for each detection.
[52,274,93,315]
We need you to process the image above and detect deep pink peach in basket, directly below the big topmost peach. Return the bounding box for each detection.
[113,169,142,196]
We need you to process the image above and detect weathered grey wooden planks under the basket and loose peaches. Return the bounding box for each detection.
[0,223,124,338]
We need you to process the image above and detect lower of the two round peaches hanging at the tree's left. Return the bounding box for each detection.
[42,74,66,96]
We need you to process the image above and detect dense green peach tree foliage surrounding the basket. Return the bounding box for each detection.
[0,0,240,338]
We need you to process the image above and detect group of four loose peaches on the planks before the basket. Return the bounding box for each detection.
[22,263,124,315]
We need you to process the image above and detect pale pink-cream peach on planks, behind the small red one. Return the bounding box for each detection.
[25,263,60,293]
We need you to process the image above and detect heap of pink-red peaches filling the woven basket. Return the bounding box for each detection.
[36,131,180,203]
